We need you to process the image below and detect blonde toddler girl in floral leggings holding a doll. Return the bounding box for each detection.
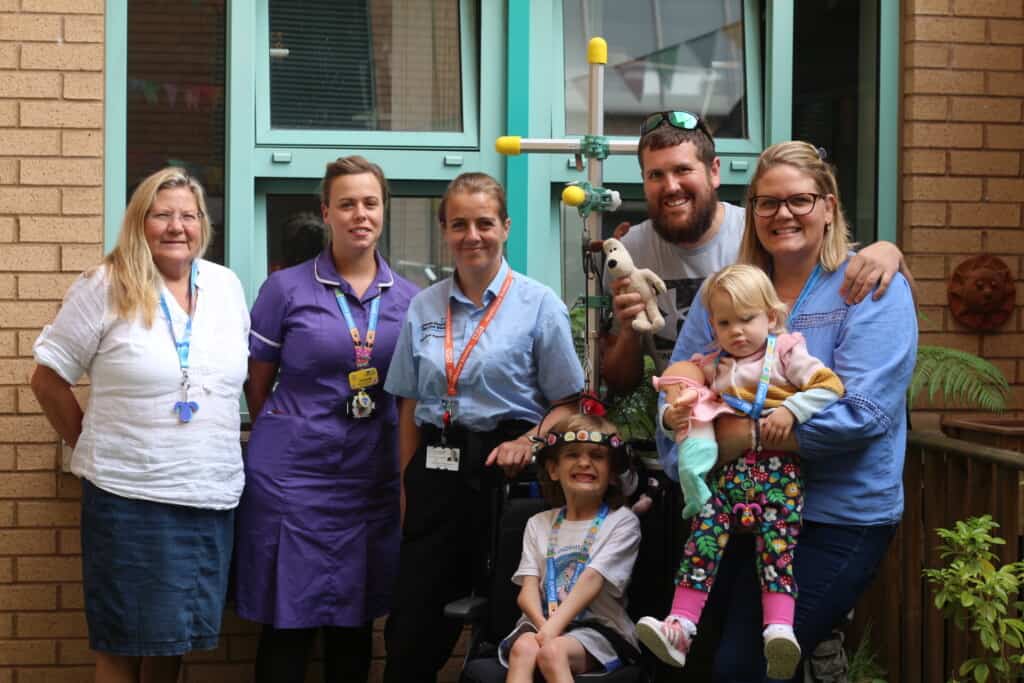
[637,265,843,679]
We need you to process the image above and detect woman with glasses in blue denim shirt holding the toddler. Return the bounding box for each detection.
[659,142,918,681]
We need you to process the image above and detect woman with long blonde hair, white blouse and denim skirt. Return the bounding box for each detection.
[32,168,249,683]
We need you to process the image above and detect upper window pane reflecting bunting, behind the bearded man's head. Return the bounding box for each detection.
[563,0,751,138]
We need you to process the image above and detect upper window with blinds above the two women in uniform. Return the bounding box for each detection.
[257,0,479,146]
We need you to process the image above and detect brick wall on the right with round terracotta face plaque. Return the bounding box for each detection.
[901,0,1024,428]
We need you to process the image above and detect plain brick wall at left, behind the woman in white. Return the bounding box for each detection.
[0,0,103,683]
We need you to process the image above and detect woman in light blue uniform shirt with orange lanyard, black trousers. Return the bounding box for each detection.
[384,173,583,683]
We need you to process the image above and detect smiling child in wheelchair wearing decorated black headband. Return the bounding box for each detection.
[499,415,640,683]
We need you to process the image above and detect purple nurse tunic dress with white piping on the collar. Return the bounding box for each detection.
[236,250,417,629]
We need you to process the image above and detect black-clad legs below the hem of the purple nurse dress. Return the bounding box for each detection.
[255,623,374,683]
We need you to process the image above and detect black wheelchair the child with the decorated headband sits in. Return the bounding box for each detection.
[444,471,650,683]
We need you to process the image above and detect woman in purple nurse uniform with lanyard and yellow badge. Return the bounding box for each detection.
[236,157,416,683]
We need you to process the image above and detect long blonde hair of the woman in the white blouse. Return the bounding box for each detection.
[100,166,213,328]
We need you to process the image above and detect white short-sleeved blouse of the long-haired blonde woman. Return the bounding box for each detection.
[33,260,249,510]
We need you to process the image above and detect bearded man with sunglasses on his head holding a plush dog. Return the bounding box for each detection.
[601,112,903,393]
